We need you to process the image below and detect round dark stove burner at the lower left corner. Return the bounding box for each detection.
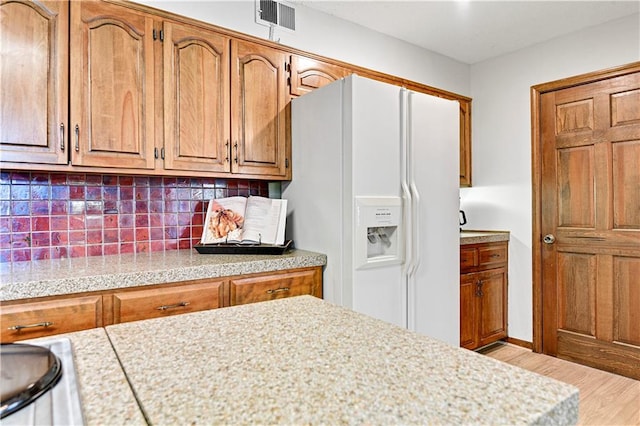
[0,343,62,418]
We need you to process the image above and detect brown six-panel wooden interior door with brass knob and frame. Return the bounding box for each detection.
[534,63,640,379]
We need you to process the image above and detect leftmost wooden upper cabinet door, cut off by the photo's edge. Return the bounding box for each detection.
[0,1,69,164]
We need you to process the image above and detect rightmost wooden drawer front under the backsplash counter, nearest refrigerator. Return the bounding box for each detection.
[230,268,322,305]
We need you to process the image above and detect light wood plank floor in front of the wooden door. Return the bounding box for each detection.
[482,343,640,426]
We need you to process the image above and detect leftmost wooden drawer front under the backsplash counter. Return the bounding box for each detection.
[0,296,102,343]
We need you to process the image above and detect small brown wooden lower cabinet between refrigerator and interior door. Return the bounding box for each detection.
[460,242,508,349]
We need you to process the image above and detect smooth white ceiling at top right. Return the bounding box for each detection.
[285,0,640,64]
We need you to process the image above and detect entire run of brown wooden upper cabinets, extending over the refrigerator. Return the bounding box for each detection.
[0,0,471,186]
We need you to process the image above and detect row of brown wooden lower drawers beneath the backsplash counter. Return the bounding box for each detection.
[0,266,322,343]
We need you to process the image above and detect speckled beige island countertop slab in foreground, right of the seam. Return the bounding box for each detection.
[106,296,578,425]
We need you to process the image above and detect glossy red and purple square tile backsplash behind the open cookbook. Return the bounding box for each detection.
[0,170,269,262]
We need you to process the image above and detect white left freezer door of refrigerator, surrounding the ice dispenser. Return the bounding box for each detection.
[343,77,407,327]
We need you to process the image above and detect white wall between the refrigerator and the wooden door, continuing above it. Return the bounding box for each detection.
[460,11,640,341]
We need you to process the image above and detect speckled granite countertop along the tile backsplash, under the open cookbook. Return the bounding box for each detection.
[0,249,327,301]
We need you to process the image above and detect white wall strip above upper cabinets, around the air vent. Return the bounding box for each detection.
[137,0,469,96]
